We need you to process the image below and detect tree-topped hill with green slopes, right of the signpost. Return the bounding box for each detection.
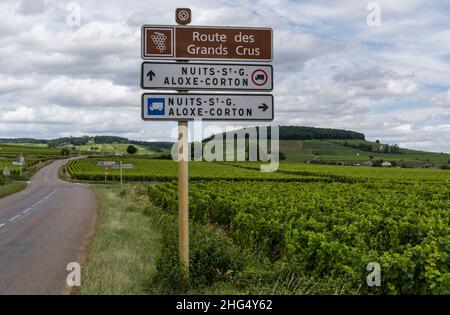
[203,126,450,167]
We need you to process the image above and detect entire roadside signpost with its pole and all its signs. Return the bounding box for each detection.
[141,8,274,278]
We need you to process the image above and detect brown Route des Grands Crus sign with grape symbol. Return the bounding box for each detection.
[142,25,273,61]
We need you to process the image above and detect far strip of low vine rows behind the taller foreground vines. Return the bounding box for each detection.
[67,156,450,182]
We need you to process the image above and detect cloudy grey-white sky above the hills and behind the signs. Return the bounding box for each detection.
[0,0,450,152]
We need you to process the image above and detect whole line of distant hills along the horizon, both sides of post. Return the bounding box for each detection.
[0,126,450,167]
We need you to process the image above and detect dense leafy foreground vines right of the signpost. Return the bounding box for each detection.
[149,165,450,294]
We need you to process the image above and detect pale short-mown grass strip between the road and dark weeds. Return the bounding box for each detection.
[75,185,160,295]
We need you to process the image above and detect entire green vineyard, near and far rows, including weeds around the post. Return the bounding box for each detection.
[62,156,450,294]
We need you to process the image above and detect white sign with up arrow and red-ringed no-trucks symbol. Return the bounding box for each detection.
[141,62,273,91]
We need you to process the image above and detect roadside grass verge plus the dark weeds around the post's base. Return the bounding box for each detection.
[76,184,359,295]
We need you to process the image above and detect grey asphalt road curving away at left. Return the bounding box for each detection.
[0,160,96,294]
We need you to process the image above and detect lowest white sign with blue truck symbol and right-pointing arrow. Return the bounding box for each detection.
[142,93,274,121]
